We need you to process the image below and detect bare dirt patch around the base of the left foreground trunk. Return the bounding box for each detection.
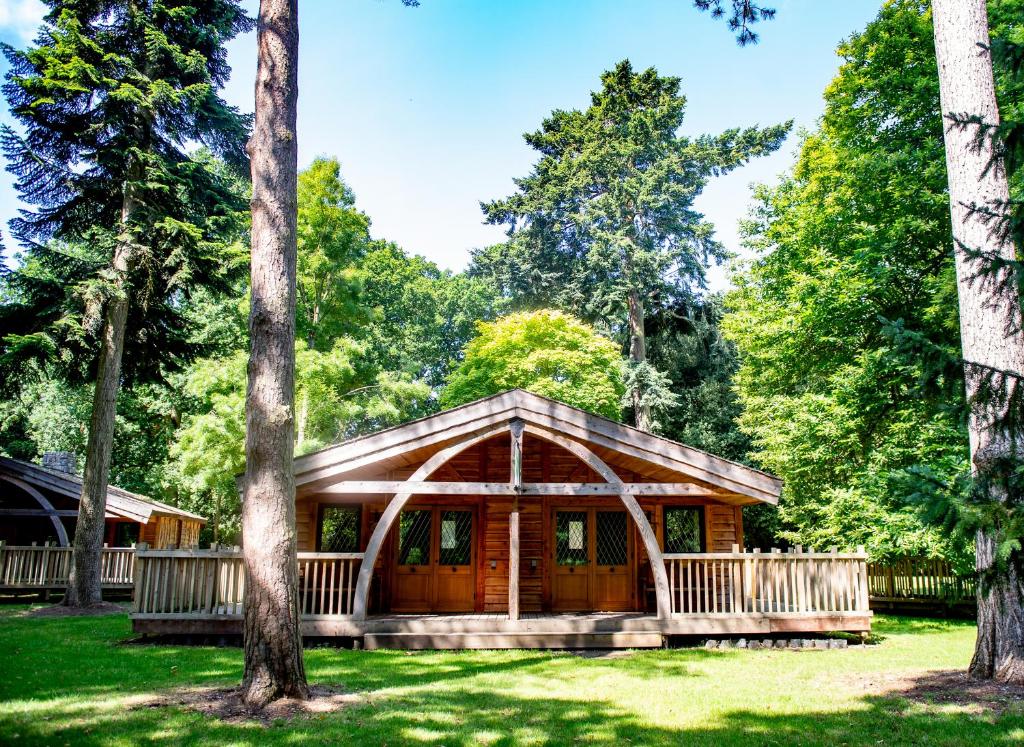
[140,686,368,727]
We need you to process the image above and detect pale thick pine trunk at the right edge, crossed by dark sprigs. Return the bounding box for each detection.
[932,0,1024,681]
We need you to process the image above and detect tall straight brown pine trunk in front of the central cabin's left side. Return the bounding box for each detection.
[242,0,308,708]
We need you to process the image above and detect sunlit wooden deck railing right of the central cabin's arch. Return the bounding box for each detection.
[665,546,868,615]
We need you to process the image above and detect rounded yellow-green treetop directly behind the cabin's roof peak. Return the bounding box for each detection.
[441,309,626,419]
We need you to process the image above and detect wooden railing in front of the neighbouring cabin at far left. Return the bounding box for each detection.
[0,542,135,589]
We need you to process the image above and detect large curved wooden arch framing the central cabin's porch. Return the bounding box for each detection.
[352,423,671,620]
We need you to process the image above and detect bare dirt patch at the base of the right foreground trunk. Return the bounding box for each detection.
[842,669,1024,716]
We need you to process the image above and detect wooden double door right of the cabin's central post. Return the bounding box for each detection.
[551,508,635,612]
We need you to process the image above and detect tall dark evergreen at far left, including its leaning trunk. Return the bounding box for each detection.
[0,0,251,605]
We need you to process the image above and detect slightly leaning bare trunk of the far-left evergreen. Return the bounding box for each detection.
[63,202,134,607]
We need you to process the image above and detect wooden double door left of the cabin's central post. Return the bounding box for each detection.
[391,506,476,612]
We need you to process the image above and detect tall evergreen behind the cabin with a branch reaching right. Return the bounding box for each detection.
[474,60,791,429]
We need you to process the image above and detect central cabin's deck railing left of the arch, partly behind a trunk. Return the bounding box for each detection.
[134,547,362,618]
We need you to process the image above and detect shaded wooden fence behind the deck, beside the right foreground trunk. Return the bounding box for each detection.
[867,557,975,604]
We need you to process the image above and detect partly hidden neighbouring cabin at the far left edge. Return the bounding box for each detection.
[0,452,206,547]
